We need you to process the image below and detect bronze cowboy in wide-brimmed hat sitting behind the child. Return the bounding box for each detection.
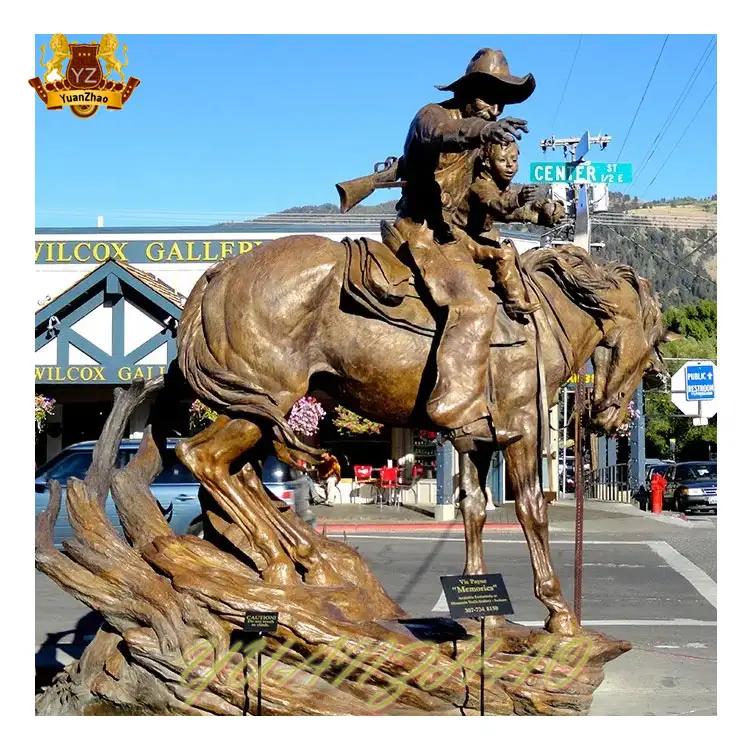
[394,49,536,452]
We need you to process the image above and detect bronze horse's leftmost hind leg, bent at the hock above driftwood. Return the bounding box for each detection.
[176,415,298,585]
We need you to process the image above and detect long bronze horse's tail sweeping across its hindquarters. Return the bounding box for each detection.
[177,260,322,464]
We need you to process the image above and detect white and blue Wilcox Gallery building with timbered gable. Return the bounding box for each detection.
[34,216,554,502]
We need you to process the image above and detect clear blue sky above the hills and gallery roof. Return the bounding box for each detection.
[29,31,717,226]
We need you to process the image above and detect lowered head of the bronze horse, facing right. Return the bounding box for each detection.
[591,266,678,433]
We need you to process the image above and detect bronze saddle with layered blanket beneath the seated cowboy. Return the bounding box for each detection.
[342,222,527,346]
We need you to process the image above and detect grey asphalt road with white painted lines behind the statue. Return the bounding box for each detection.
[36,513,716,715]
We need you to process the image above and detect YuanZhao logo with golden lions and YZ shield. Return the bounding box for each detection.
[29,34,140,118]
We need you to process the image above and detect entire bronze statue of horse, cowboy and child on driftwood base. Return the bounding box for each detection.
[36,45,667,715]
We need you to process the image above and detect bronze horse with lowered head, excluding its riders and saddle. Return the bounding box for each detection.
[178,235,668,634]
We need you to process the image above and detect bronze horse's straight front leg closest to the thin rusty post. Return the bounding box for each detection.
[505,409,580,635]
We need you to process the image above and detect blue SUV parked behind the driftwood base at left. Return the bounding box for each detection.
[34,439,315,547]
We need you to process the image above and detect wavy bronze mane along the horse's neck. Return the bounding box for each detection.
[520,245,661,331]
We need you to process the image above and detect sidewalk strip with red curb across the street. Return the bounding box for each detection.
[312,498,691,533]
